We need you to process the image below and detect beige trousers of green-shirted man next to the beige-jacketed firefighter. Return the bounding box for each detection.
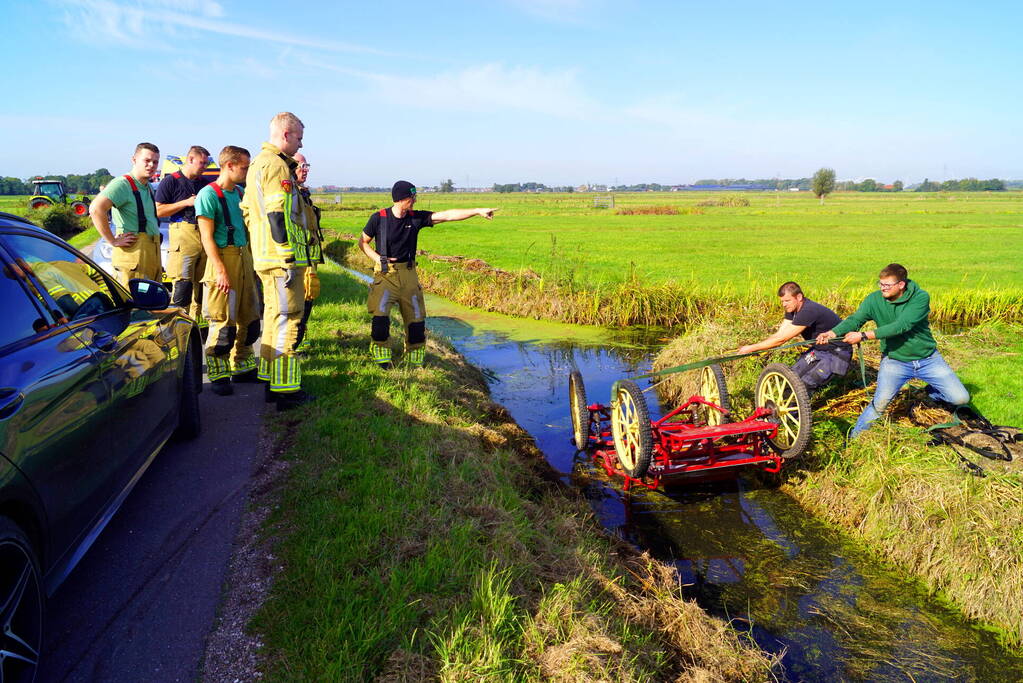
[203,246,259,381]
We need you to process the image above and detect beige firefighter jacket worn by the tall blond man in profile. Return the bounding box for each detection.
[241,142,309,271]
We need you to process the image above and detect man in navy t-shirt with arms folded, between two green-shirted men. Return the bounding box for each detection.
[157,145,212,324]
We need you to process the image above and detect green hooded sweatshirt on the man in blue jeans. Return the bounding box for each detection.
[832,280,938,361]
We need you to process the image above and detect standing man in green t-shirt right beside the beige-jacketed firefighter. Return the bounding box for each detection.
[195,145,259,396]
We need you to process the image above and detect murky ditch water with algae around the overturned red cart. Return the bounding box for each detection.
[428,300,1023,681]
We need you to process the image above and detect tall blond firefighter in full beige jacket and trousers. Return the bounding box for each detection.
[241,112,318,410]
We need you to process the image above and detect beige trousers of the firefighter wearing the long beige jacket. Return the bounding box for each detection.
[259,268,306,393]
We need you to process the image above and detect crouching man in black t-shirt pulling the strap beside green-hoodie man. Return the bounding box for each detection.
[739,282,852,392]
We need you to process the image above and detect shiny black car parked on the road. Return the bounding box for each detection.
[0,214,203,681]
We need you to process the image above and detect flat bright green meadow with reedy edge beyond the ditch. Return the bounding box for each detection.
[322,187,1023,326]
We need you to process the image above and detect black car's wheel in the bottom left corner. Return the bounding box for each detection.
[0,516,46,681]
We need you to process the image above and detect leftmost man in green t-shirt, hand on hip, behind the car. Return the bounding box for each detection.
[89,142,164,287]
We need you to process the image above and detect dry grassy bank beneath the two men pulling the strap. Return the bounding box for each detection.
[656,311,1023,646]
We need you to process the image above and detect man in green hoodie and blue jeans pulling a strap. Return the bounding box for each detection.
[817,263,970,437]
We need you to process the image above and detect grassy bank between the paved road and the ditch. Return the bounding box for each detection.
[256,259,770,680]
